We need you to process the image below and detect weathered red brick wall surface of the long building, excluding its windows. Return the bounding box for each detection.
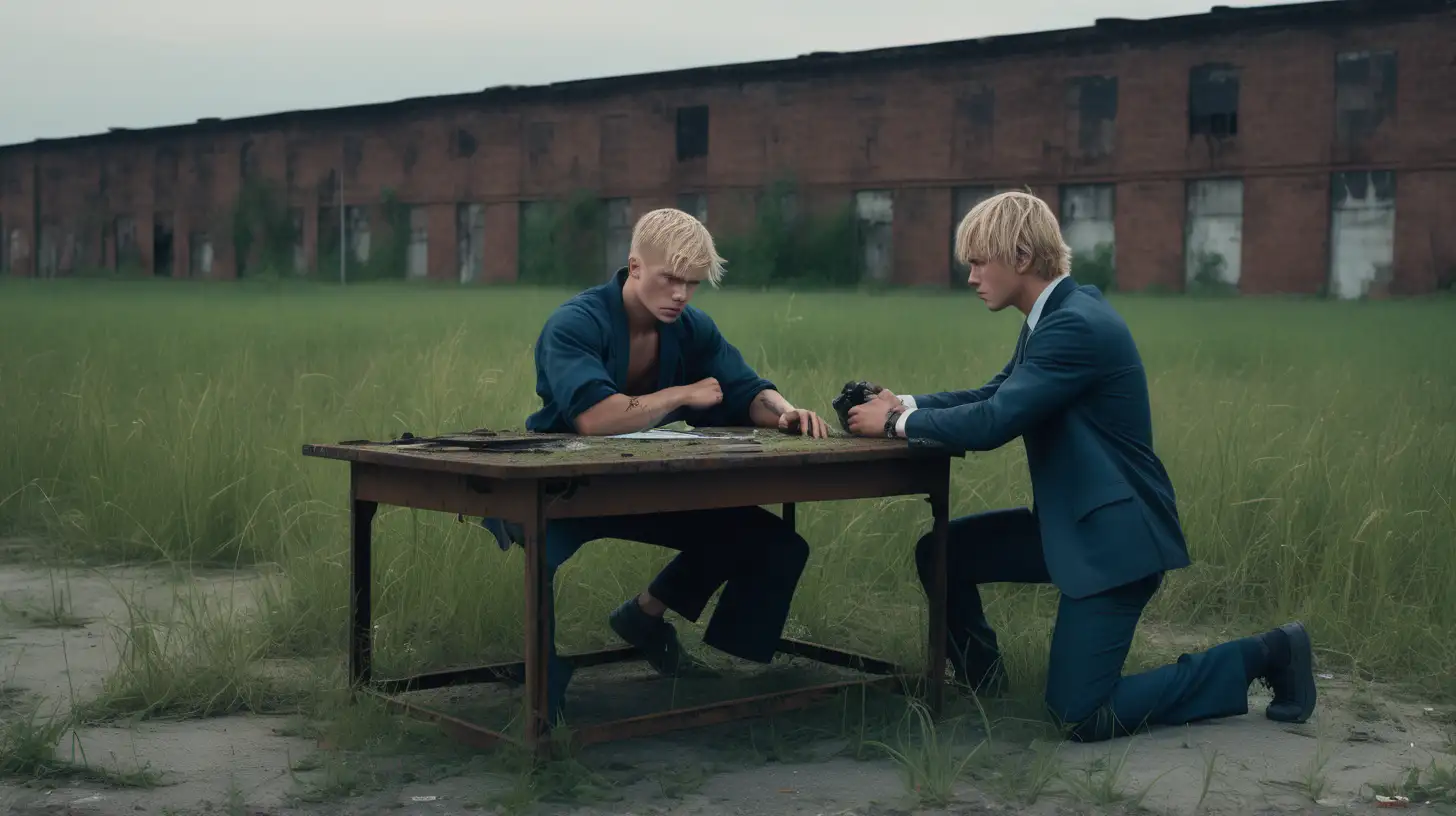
[0,5,1456,293]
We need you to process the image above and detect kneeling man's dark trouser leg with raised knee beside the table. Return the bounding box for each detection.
[916,507,1051,688]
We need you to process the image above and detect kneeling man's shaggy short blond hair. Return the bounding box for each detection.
[955,191,1072,280]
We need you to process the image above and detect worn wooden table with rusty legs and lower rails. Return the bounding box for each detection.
[303,428,951,752]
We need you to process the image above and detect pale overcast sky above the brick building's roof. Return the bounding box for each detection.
[0,0,1316,144]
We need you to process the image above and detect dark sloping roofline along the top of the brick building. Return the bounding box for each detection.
[0,0,1456,153]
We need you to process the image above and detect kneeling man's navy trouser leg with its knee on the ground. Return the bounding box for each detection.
[1047,576,1249,742]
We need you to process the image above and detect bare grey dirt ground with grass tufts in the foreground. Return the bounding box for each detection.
[0,565,1456,816]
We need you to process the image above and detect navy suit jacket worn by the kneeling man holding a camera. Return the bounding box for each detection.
[904,277,1190,597]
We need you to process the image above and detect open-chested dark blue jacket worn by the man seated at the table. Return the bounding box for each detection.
[526,267,775,433]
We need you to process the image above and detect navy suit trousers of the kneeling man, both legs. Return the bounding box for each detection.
[916,507,1249,742]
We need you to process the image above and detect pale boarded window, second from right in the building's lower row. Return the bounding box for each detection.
[1184,179,1243,291]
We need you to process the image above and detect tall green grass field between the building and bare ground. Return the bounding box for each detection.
[0,281,1456,722]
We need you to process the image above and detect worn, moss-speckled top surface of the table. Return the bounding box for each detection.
[303,428,951,479]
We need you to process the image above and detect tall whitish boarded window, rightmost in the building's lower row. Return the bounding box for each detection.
[1329,170,1395,300]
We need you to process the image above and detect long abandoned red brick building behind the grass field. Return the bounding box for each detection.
[0,0,1456,297]
